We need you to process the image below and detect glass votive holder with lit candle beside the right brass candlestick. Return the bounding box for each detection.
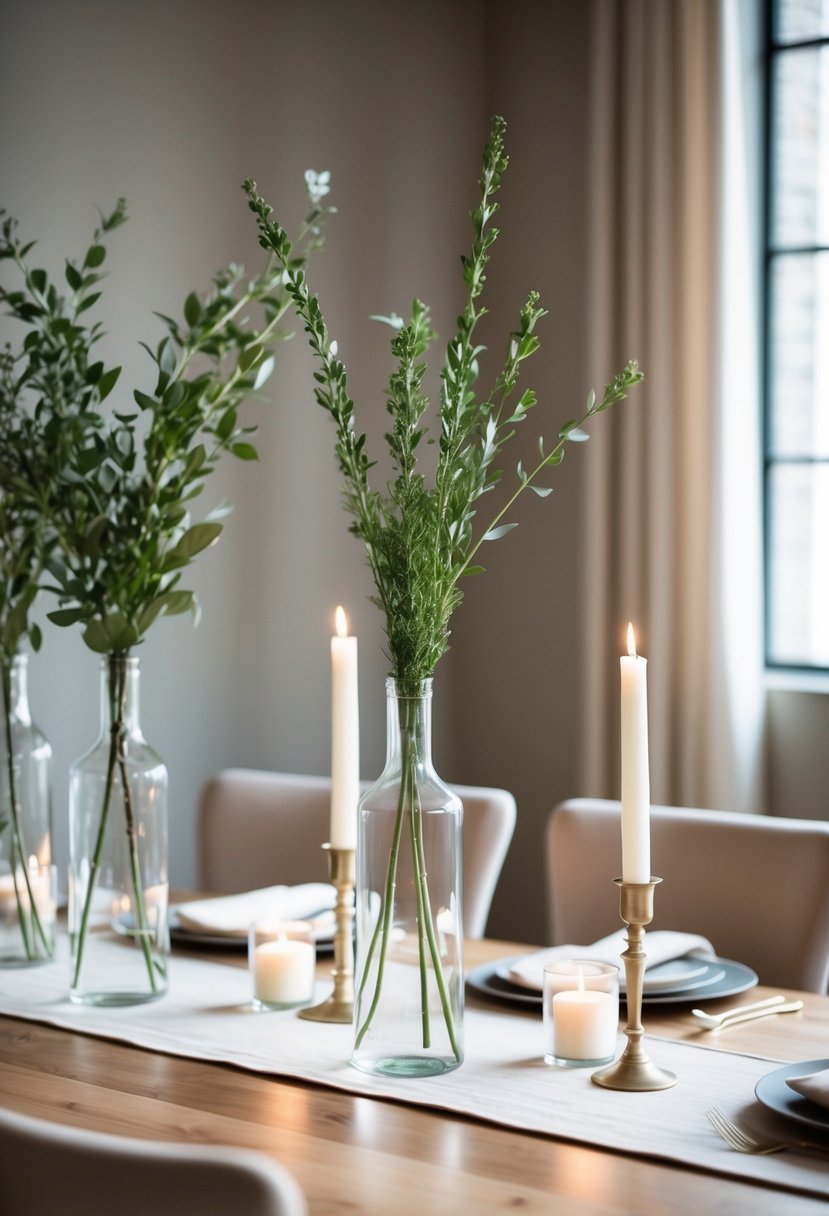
[543,958,619,1068]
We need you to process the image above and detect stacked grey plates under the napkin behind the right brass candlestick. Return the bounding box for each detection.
[467,956,757,1009]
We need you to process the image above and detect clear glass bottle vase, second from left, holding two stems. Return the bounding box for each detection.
[69,654,169,1006]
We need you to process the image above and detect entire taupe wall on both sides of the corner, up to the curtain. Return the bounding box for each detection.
[0,0,593,938]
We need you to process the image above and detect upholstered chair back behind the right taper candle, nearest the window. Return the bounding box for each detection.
[546,798,829,992]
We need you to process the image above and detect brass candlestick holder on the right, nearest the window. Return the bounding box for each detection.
[583,878,676,1091]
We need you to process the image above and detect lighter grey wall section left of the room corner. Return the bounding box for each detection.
[0,0,478,883]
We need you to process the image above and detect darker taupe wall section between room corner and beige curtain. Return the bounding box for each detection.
[447,2,593,941]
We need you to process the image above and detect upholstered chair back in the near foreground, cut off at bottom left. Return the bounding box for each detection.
[0,1110,308,1216]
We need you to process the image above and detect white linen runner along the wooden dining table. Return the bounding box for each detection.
[0,935,829,1198]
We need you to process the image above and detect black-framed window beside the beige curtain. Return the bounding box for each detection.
[765,0,829,669]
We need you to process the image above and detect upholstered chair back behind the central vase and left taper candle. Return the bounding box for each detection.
[198,769,515,938]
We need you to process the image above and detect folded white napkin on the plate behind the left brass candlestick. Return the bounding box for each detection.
[175,883,337,938]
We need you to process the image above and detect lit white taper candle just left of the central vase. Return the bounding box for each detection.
[331,607,360,849]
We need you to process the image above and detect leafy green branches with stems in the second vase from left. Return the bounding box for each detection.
[0,170,333,990]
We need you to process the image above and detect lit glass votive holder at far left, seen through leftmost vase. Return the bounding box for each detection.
[0,863,57,967]
